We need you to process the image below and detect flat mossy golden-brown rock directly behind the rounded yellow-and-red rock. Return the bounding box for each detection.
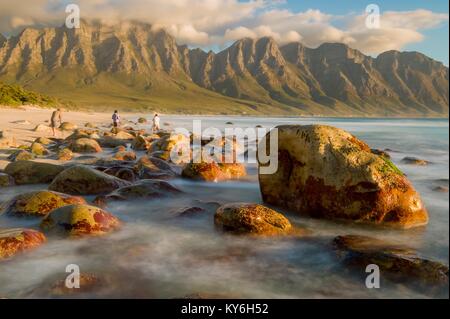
[0,190,86,217]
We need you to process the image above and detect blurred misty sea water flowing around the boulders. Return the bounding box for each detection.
[0,116,449,298]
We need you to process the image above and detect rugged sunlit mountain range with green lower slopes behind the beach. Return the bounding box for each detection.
[0,20,449,117]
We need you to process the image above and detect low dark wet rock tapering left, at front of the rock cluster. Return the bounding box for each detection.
[94,179,182,203]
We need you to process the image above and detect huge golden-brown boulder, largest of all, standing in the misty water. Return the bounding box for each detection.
[259,125,428,228]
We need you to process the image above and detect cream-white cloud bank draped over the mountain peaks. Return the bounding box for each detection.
[0,0,448,54]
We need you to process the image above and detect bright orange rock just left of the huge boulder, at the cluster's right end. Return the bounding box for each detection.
[182,162,246,182]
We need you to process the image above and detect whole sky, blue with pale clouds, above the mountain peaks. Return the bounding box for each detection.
[0,0,449,66]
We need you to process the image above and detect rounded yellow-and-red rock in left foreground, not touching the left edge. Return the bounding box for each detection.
[41,205,121,236]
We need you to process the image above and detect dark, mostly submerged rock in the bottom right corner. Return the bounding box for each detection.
[333,235,448,293]
